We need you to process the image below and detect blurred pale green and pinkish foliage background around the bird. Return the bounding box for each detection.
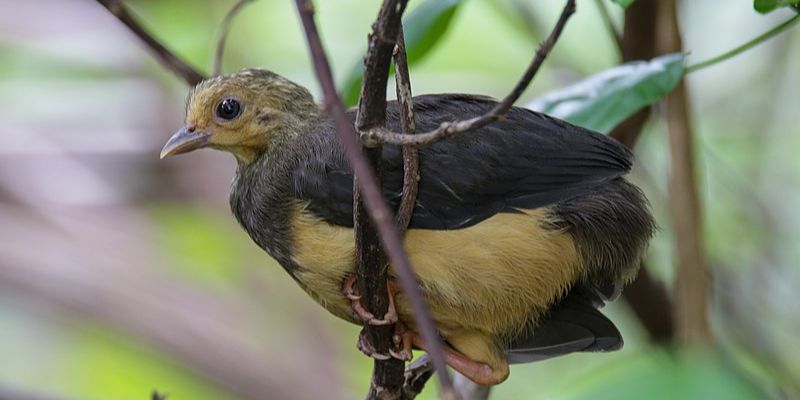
[0,0,800,400]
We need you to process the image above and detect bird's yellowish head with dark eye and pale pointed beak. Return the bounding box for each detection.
[161,69,320,165]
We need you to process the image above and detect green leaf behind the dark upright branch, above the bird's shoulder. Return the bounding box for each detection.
[341,0,461,106]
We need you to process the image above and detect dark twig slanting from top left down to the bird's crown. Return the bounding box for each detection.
[97,0,205,86]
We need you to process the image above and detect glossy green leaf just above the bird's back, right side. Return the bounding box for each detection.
[526,53,685,133]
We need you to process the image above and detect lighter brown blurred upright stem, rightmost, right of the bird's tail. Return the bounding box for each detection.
[658,0,712,344]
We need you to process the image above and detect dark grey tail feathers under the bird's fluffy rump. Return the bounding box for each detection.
[506,287,623,364]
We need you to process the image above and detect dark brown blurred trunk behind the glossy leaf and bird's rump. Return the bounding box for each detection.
[611,0,674,342]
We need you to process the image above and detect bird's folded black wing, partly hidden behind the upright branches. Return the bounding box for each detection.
[295,95,632,229]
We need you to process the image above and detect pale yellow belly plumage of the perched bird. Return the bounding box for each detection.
[292,205,582,338]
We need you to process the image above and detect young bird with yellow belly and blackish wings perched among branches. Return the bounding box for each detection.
[161,69,654,384]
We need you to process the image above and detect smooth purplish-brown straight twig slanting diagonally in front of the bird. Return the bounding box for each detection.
[295,0,452,393]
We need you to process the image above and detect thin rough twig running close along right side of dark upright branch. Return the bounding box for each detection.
[394,26,419,235]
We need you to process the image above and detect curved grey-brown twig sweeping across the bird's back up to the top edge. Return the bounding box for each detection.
[362,0,575,146]
